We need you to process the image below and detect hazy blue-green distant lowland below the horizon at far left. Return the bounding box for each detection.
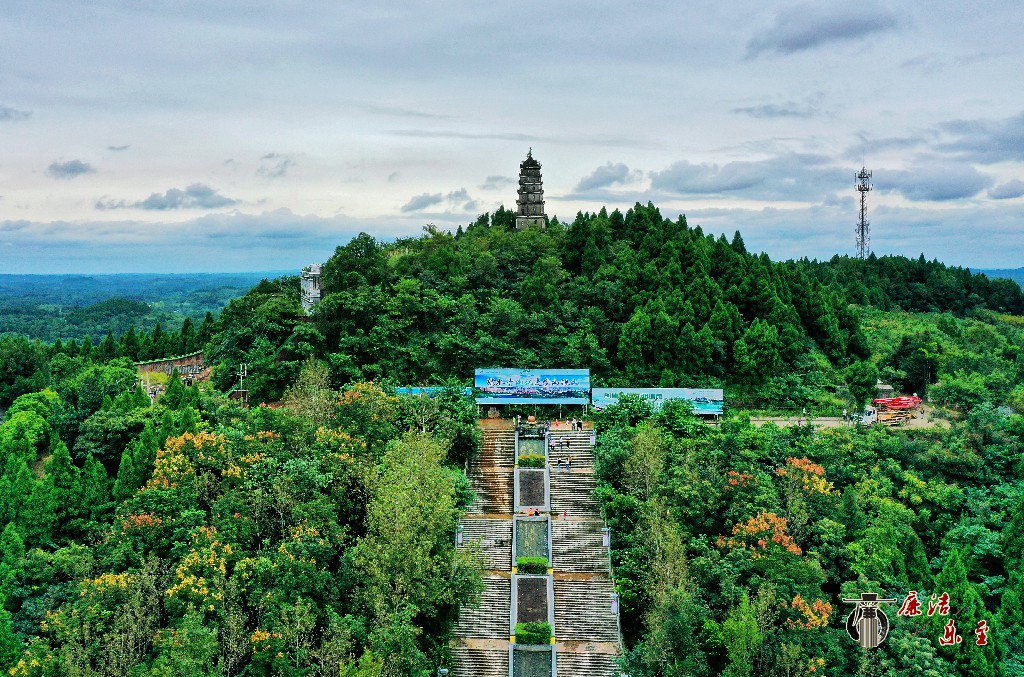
[0,270,282,342]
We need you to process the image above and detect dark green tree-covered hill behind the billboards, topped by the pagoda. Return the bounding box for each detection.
[208,204,1024,404]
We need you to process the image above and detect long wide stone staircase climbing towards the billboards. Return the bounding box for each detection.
[451,420,621,677]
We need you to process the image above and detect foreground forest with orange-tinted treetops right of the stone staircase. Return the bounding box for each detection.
[596,398,1024,677]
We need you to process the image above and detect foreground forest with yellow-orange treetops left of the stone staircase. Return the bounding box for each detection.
[0,354,481,677]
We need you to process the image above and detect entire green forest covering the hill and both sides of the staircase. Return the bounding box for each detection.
[0,205,1024,677]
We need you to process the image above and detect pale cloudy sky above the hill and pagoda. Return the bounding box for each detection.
[0,0,1024,272]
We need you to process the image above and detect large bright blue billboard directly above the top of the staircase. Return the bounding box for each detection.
[474,369,590,405]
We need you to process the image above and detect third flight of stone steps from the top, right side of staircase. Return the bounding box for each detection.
[555,579,618,643]
